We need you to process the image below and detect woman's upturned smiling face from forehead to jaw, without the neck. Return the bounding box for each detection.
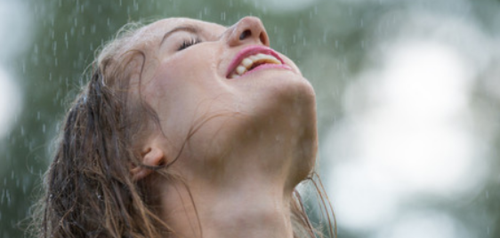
[137,17,316,180]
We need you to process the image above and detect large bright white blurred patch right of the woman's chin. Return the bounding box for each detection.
[329,42,485,238]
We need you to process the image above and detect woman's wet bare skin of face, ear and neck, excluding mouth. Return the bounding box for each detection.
[132,17,317,237]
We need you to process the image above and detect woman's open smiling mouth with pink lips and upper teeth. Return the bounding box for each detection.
[226,46,290,79]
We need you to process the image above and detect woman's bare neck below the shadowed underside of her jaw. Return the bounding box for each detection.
[157,173,293,238]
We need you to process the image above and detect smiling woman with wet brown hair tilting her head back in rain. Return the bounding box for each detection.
[36,17,336,238]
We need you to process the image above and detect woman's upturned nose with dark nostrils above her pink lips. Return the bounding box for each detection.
[227,17,269,47]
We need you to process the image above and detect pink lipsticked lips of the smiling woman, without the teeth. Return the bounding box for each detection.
[226,45,290,78]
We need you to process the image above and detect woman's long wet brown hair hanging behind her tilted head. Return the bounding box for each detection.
[33,20,336,238]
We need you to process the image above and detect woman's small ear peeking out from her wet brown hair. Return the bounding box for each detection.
[130,146,166,181]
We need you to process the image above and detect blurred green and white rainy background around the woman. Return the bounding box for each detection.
[0,0,500,238]
